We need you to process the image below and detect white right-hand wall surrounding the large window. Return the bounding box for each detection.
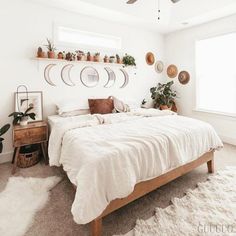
[165,15,236,145]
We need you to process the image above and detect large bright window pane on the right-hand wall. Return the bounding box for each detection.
[196,33,236,115]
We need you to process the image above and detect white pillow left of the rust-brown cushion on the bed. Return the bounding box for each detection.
[56,100,89,115]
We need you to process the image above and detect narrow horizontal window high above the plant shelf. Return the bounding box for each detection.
[56,26,121,50]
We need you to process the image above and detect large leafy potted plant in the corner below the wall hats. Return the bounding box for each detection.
[150,81,177,110]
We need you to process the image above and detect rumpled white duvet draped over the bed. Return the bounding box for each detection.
[49,109,223,224]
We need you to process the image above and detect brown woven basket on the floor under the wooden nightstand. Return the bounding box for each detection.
[17,148,40,168]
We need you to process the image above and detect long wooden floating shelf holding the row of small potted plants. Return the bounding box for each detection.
[32,57,131,67]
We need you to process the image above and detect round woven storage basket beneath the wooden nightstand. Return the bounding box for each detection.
[17,145,40,168]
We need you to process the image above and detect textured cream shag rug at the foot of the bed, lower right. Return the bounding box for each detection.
[126,167,236,236]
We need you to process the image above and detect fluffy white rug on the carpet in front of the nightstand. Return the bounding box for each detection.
[0,176,61,236]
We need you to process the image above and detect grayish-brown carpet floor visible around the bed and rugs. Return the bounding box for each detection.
[0,144,236,236]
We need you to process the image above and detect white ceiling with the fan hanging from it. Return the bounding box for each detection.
[32,0,236,33]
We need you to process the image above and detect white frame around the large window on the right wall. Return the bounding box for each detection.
[193,29,236,119]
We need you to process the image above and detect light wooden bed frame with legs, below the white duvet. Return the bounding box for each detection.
[85,151,214,236]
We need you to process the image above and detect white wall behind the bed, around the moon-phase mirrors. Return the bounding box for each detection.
[0,0,164,162]
